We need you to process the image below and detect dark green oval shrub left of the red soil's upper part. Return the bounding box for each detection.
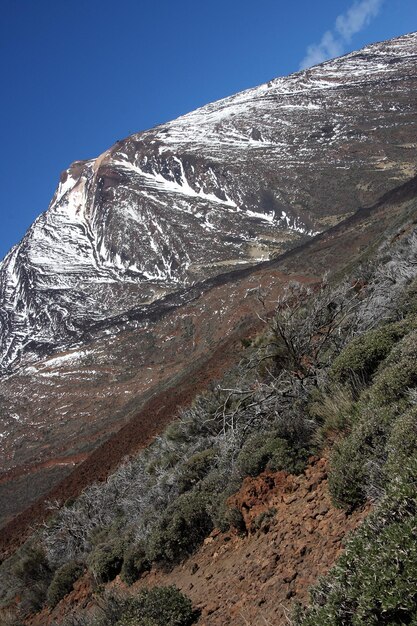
[147,491,213,563]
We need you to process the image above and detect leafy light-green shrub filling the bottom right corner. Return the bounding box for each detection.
[294,476,417,626]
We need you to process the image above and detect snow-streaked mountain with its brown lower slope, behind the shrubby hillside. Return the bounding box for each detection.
[0,33,417,532]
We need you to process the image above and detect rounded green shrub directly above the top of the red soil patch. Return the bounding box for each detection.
[237,432,308,476]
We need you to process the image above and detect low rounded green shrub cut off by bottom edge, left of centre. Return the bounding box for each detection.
[116,587,198,626]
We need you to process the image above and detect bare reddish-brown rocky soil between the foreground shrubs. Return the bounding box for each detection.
[28,457,370,626]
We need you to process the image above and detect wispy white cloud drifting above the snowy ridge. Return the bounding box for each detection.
[300,0,384,70]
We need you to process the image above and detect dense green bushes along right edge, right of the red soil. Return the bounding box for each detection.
[294,235,417,626]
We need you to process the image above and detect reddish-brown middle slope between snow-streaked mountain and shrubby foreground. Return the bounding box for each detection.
[0,173,417,542]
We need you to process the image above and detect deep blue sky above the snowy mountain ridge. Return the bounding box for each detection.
[0,0,417,259]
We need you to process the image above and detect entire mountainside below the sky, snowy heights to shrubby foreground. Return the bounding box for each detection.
[0,33,417,626]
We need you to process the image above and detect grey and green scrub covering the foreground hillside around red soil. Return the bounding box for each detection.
[1,224,417,626]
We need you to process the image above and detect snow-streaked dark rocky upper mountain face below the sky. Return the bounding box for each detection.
[0,34,417,371]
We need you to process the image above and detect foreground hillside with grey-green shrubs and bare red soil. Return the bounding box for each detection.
[0,173,417,626]
